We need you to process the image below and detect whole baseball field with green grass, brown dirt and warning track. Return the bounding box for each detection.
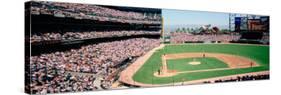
[121,44,269,85]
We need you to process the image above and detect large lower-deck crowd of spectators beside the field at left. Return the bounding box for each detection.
[30,38,160,94]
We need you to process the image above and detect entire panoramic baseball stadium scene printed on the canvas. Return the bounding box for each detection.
[25,1,270,95]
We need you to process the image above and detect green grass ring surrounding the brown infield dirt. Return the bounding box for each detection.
[133,44,269,84]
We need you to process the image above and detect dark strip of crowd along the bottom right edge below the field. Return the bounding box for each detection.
[204,74,269,83]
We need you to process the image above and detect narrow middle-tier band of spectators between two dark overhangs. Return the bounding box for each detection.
[30,30,160,43]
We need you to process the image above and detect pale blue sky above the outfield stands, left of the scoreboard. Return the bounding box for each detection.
[162,9,229,26]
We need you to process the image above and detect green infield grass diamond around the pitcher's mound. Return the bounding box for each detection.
[167,57,228,72]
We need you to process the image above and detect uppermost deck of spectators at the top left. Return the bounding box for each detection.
[31,1,161,24]
